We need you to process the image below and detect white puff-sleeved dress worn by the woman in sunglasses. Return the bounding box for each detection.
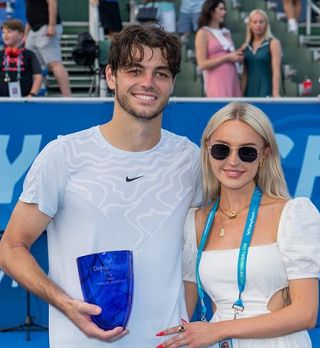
[183,197,320,348]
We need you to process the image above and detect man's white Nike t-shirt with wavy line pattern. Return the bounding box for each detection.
[20,126,201,348]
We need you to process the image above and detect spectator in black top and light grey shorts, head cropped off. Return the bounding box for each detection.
[25,0,71,97]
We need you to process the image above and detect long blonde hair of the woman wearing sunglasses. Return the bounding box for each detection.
[201,102,290,205]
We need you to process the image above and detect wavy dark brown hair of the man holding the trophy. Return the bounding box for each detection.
[108,24,181,78]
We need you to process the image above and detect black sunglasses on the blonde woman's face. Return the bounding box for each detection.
[208,144,258,162]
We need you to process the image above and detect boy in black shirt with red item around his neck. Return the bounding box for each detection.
[0,19,42,97]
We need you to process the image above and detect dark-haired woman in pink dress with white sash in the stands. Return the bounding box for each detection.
[195,0,243,98]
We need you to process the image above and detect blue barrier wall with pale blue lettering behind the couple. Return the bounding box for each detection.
[0,98,320,327]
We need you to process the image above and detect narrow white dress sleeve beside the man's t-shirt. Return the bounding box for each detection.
[182,208,198,283]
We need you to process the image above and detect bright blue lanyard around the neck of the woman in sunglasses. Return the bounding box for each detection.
[196,186,262,321]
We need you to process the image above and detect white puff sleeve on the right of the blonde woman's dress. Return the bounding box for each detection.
[278,197,320,280]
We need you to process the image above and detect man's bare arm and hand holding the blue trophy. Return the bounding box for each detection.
[0,201,127,341]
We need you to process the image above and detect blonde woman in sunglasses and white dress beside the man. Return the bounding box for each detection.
[158,103,320,348]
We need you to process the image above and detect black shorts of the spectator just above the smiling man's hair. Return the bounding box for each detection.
[90,0,122,37]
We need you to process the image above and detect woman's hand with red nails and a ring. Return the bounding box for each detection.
[157,321,219,348]
